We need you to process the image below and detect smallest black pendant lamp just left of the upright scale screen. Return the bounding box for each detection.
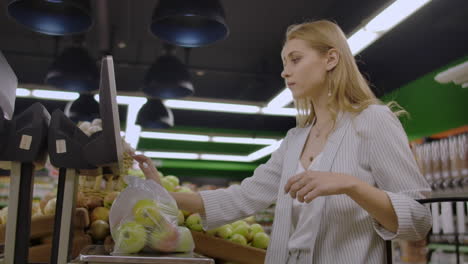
[64,94,99,123]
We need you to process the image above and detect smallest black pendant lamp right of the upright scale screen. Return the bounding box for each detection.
[136,99,174,130]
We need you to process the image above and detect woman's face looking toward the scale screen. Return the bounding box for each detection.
[281,39,327,99]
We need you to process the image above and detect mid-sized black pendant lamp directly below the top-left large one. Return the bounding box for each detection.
[45,47,99,93]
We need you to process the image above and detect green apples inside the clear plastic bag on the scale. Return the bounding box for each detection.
[112,199,194,254]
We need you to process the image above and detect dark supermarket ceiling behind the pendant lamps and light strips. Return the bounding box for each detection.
[0,0,468,179]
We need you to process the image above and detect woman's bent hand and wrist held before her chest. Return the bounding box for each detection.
[284,171,357,203]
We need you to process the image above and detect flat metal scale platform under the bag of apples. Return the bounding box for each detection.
[72,245,215,264]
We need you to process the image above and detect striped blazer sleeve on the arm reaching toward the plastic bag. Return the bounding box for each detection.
[200,130,290,230]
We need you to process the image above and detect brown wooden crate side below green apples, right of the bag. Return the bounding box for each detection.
[192,231,266,264]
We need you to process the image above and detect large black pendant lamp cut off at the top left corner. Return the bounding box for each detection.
[8,0,93,36]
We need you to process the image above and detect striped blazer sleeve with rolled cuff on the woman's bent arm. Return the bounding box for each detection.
[369,106,432,240]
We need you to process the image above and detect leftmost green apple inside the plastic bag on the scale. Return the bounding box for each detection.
[113,221,146,254]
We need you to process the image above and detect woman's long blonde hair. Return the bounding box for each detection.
[285,20,405,127]
